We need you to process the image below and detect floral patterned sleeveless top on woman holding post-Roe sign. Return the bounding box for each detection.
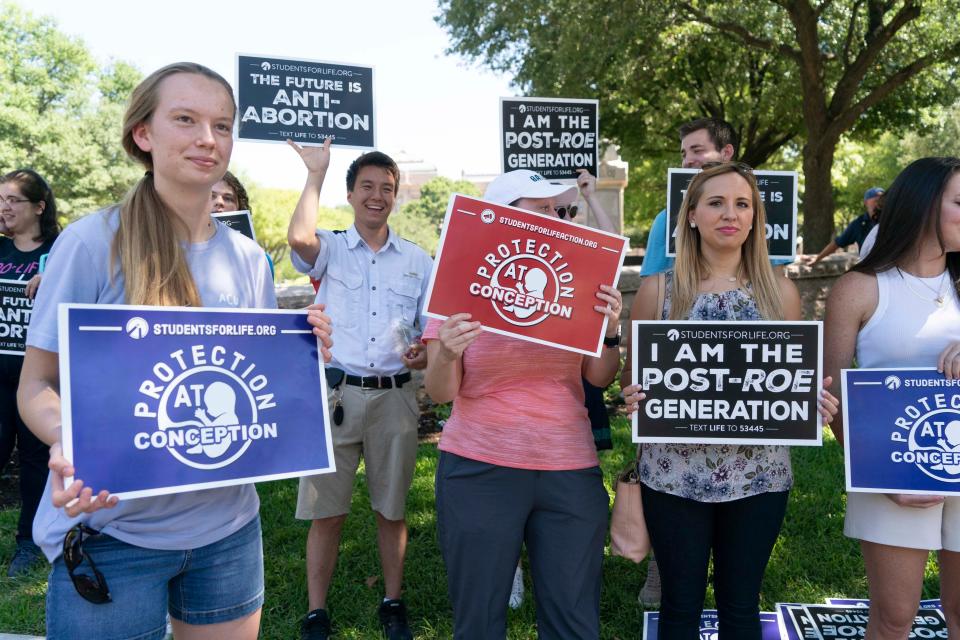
[637,271,793,502]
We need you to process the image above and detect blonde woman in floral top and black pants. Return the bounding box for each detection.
[624,163,837,640]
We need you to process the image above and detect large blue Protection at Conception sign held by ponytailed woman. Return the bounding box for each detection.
[59,304,334,498]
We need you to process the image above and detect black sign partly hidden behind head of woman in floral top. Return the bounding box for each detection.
[667,169,798,260]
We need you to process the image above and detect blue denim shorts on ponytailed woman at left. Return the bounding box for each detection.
[47,516,263,640]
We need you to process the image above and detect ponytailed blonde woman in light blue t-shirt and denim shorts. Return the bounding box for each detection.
[19,63,330,640]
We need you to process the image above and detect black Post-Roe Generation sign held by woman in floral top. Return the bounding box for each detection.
[631,320,823,446]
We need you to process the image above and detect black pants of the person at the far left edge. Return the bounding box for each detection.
[0,356,50,540]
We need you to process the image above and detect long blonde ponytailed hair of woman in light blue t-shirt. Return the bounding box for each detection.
[110,62,236,307]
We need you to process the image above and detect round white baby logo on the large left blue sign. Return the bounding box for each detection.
[133,345,278,469]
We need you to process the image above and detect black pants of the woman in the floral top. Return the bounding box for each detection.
[642,485,789,640]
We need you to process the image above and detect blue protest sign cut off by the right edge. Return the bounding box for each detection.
[842,369,960,495]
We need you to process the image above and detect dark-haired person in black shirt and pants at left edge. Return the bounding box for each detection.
[0,169,60,577]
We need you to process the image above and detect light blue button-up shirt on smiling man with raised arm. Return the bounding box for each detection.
[290,226,433,376]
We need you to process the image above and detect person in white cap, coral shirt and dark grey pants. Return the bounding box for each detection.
[423,170,622,639]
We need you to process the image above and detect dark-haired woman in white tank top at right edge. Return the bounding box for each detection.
[824,158,960,640]
